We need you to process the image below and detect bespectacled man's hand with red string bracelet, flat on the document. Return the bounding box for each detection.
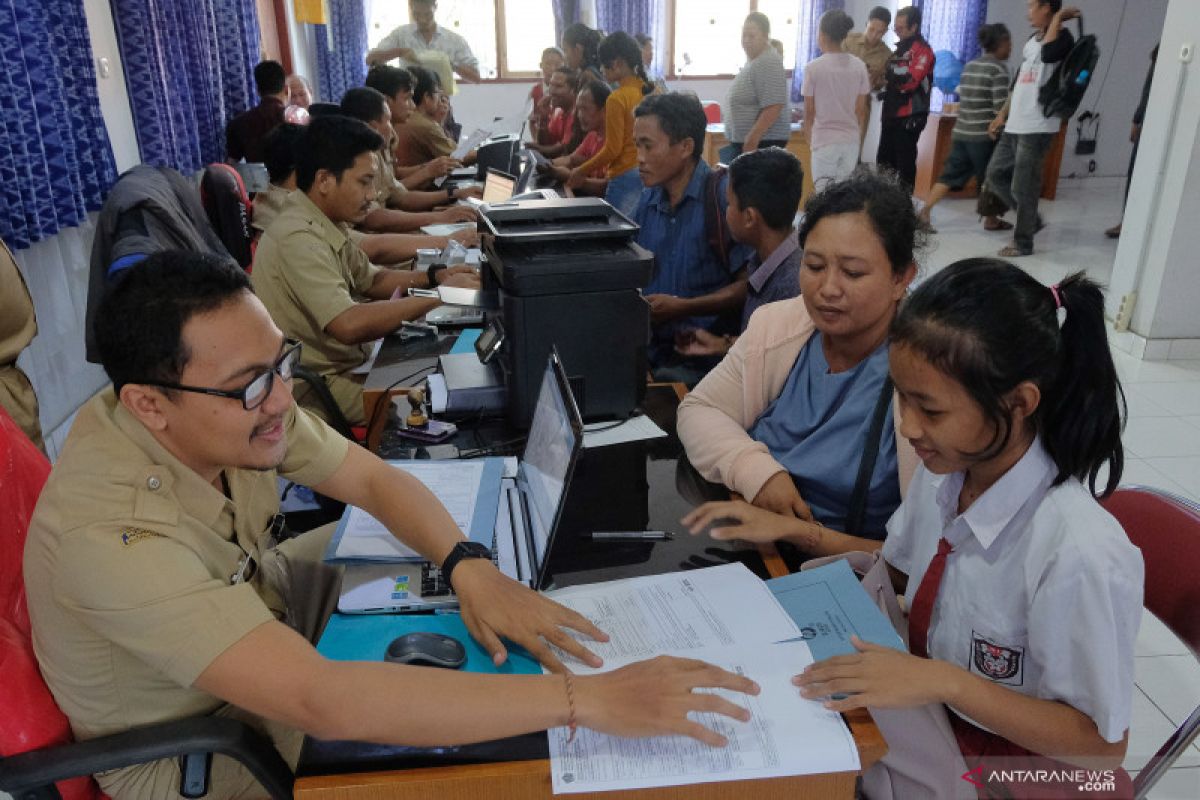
[575,656,758,747]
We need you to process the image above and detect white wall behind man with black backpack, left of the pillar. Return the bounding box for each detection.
[988,0,1166,178]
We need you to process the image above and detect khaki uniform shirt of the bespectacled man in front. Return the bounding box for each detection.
[24,389,349,739]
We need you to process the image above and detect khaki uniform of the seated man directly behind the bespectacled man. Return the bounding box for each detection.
[251,192,379,425]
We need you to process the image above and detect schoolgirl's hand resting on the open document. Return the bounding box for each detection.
[792,636,961,711]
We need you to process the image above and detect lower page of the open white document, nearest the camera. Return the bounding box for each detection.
[548,642,859,796]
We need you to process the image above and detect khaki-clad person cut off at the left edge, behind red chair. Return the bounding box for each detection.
[0,242,46,450]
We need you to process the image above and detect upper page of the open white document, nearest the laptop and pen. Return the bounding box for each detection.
[546,563,800,674]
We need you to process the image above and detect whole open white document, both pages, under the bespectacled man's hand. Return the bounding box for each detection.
[547,564,859,794]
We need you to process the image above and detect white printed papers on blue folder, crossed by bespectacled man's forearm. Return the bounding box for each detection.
[334,461,484,560]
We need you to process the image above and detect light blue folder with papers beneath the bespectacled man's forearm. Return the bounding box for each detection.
[325,458,504,564]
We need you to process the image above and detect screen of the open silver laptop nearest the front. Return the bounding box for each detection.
[521,354,582,572]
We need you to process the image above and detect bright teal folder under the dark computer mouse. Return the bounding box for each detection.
[317,614,541,675]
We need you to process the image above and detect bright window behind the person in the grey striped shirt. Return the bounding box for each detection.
[670,0,800,78]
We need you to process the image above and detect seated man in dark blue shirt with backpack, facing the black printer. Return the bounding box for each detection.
[634,92,751,386]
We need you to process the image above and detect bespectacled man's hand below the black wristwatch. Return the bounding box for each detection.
[454,559,608,672]
